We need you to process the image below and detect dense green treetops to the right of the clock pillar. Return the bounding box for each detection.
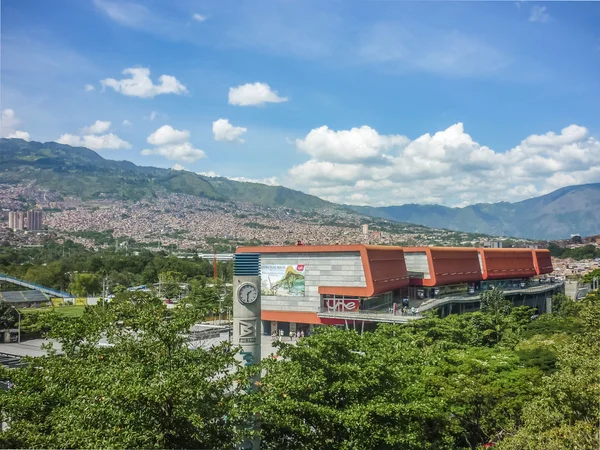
[253,295,600,450]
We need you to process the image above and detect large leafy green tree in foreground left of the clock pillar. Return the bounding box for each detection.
[0,292,248,449]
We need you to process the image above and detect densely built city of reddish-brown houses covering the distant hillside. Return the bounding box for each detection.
[0,185,534,251]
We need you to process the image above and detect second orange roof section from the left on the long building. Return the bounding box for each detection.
[404,247,483,286]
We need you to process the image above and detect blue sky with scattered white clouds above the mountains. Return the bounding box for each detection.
[0,0,600,206]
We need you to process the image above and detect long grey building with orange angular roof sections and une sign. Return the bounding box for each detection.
[236,245,564,335]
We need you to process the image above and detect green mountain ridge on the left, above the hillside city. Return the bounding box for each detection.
[0,139,330,209]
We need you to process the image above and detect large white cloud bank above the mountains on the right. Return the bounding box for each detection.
[286,123,600,206]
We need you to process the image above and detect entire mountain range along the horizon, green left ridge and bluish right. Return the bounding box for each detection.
[0,139,600,239]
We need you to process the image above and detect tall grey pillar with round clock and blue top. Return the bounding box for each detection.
[233,253,261,450]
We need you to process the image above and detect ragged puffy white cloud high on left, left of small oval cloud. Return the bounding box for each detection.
[100,67,188,98]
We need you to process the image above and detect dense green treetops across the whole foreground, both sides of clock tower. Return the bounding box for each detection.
[0,284,600,450]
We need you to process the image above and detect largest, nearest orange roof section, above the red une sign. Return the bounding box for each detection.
[235,244,408,297]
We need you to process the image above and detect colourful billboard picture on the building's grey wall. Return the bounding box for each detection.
[261,264,304,297]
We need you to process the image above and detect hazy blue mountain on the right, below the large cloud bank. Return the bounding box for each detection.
[351,183,600,239]
